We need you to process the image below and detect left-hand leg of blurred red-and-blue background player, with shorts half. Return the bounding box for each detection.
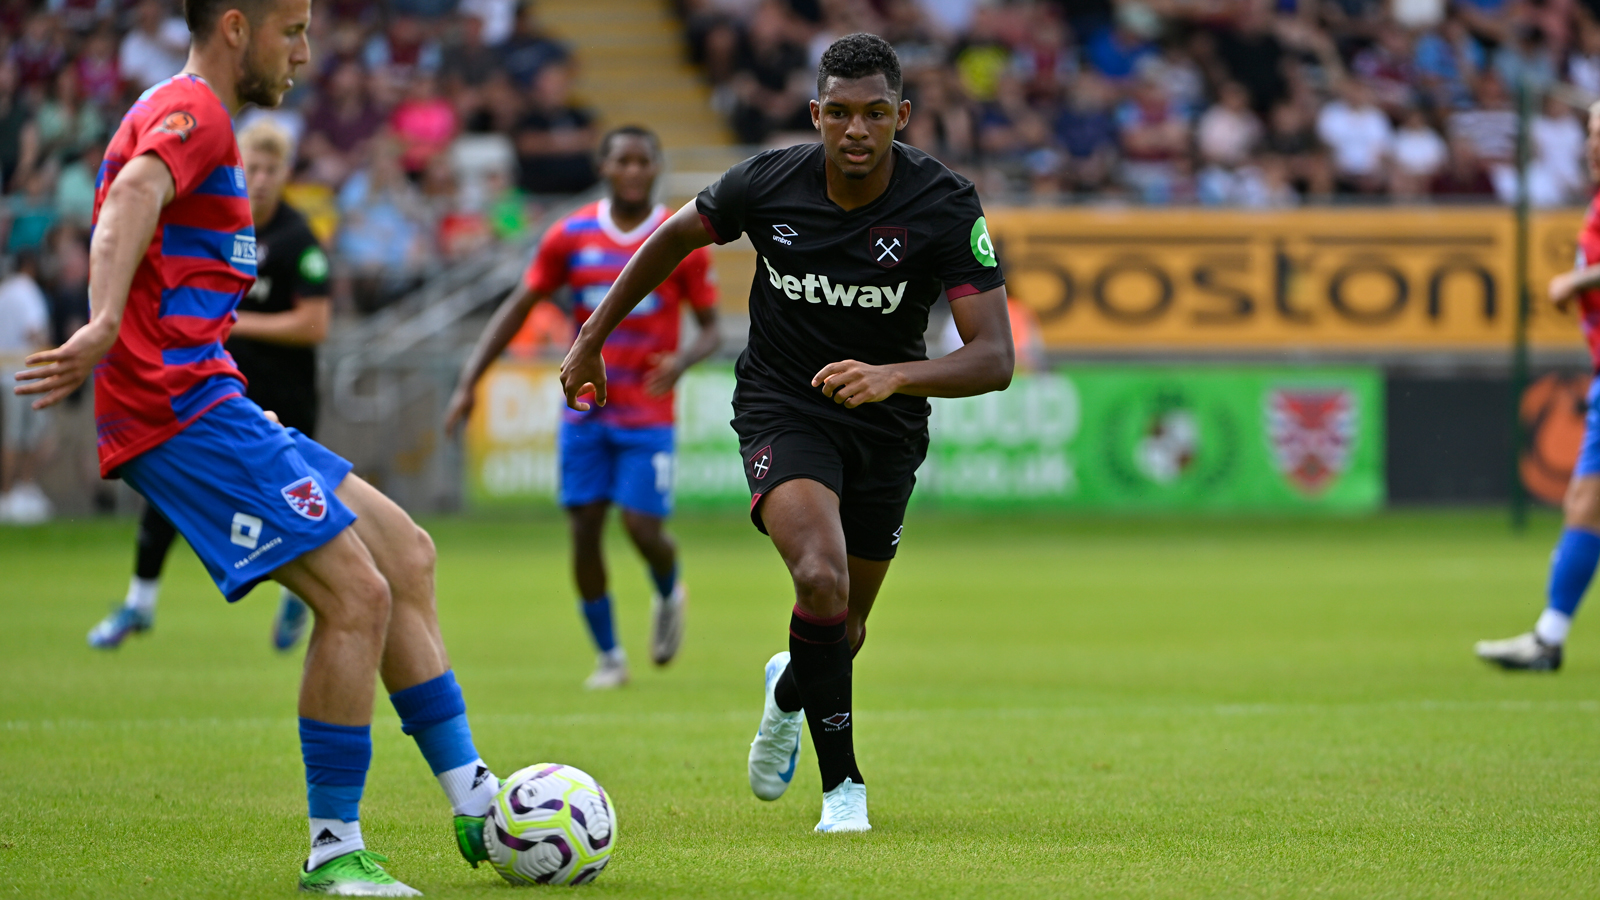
[557,420,629,690]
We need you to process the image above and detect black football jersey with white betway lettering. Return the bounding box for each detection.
[696,143,1005,440]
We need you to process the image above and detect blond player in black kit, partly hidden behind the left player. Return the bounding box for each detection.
[90,119,331,650]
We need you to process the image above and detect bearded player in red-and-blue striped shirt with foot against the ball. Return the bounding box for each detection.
[16,0,498,897]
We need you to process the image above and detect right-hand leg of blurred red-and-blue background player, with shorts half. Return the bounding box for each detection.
[611,426,688,666]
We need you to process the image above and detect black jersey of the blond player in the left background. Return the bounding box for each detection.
[227,203,328,408]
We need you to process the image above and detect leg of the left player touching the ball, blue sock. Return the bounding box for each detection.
[331,464,499,866]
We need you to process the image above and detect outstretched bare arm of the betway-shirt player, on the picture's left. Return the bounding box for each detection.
[562,200,712,410]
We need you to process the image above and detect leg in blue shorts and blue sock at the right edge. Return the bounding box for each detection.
[1474,378,1600,671]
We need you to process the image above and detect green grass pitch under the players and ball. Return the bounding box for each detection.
[0,512,1600,900]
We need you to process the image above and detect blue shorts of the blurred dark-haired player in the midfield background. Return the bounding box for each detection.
[557,418,674,519]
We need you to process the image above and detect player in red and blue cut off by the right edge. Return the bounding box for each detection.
[1475,102,1600,673]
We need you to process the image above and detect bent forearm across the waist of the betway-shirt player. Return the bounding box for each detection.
[811,285,1016,408]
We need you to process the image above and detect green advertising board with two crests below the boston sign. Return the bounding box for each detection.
[467,360,1384,512]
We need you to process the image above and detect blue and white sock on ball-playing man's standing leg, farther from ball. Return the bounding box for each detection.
[299,717,373,871]
